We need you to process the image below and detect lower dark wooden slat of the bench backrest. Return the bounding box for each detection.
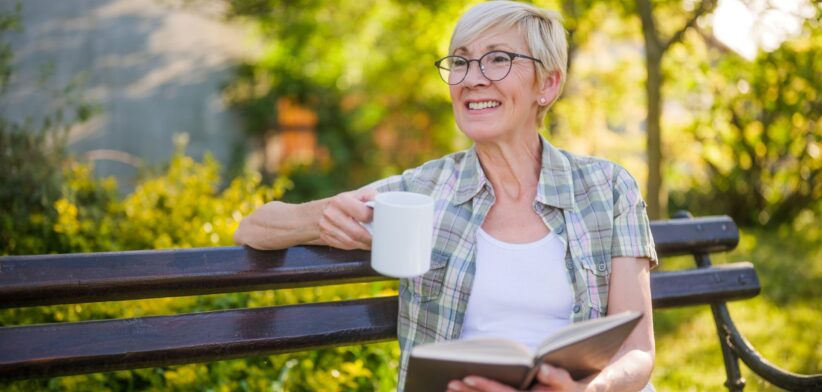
[0,262,759,379]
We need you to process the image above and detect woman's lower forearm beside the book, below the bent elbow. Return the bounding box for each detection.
[587,349,654,392]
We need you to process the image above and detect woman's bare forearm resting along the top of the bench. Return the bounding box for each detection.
[234,199,328,249]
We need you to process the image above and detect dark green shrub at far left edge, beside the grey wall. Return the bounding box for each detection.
[0,3,96,255]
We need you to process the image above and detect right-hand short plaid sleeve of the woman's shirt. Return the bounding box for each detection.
[611,166,659,269]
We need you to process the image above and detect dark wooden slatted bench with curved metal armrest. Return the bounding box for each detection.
[0,216,822,391]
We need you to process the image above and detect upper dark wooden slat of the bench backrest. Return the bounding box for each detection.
[0,216,739,308]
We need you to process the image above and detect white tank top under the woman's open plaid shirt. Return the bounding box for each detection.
[460,228,574,350]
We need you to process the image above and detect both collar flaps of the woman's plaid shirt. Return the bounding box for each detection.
[454,135,574,209]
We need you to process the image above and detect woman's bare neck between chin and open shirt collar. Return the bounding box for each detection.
[476,132,542,202]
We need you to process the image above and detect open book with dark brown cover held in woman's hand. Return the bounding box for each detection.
[405,312,642,392]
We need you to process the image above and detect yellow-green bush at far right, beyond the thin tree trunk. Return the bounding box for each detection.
[678,21,822,226]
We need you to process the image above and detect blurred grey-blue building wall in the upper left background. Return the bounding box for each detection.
[0,0,253,189]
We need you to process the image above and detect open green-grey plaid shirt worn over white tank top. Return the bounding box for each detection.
[370,136,657,391]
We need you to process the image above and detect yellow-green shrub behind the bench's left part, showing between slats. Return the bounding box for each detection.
[0,144,399,391]
